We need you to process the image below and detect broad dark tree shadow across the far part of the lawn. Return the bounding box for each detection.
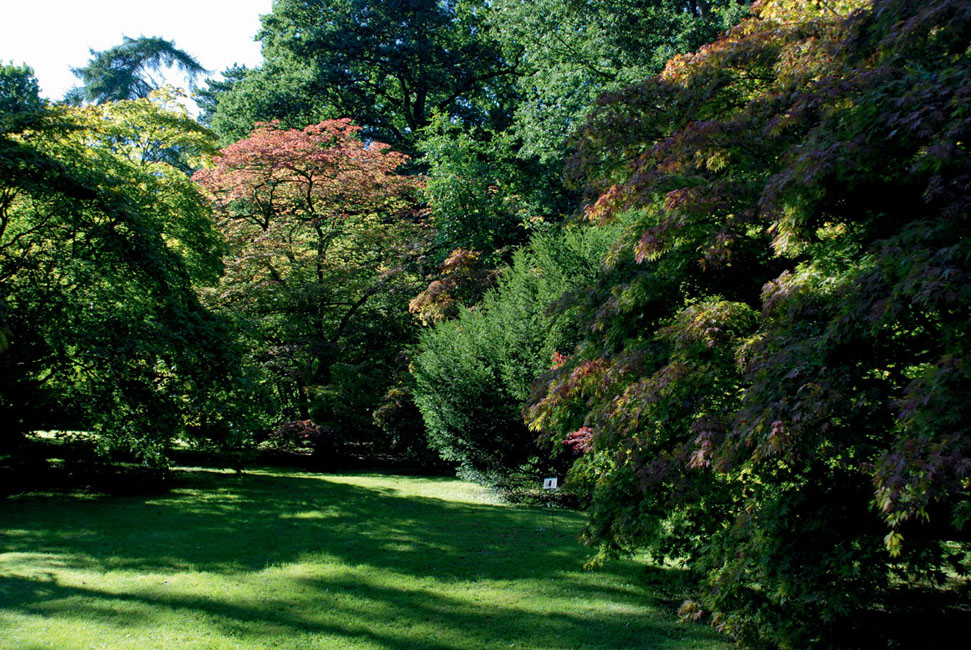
[7,472,600,579]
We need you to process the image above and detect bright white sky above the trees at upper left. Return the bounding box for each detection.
[0,0,273,100]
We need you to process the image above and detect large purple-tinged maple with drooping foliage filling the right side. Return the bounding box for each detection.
[529,0,971,648]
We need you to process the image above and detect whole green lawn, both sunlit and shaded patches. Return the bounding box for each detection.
[0,470,727,650]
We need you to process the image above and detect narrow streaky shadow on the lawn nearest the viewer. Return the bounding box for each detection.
[0,578,707,650]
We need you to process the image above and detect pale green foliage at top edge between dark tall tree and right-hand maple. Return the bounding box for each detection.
[490,0,748,165]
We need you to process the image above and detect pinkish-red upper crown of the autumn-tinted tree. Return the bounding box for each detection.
[194,119,416,292]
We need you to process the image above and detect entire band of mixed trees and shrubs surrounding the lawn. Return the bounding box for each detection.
[0,0,971,648]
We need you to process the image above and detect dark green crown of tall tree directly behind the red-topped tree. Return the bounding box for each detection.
[207,0,514,153]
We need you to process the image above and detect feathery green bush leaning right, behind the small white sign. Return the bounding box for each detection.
[413,229,611,483]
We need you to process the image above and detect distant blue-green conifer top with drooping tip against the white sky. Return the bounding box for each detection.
[68,36,206,104]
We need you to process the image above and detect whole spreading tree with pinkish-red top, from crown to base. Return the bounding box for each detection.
[195,120,420,438]
